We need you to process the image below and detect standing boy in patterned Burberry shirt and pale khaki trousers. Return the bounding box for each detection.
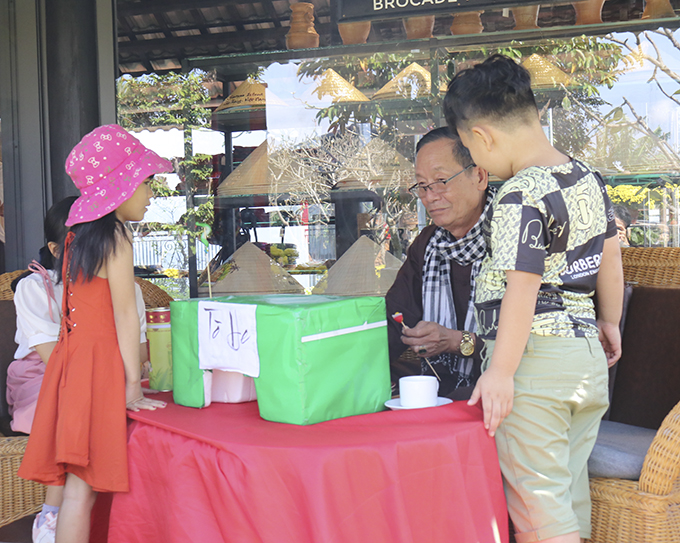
[444,55,623,543]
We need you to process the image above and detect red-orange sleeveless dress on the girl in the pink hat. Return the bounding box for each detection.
[18,232,129,492]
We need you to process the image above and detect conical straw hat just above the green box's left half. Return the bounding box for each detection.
[203,242,305,294]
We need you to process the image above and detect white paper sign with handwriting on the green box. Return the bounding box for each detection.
[198,302,260,377]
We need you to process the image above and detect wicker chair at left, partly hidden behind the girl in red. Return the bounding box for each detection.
[0,270,172,527]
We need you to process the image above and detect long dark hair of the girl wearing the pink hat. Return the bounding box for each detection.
[58,211,128,281]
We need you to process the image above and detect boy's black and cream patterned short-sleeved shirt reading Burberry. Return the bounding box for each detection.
[475,160,616,339]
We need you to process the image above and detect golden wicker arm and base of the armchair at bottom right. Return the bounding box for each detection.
[590,403,680,543]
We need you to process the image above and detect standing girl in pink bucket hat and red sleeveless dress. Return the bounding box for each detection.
[19,125,172,543]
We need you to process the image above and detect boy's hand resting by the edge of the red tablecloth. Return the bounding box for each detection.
[468,367,515,437]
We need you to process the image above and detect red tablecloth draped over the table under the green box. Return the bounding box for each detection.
[109,394,508,543]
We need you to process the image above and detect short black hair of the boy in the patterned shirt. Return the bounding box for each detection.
[444,55,538,131]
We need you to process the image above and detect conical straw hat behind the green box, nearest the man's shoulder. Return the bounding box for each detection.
[312,236,401,296]
